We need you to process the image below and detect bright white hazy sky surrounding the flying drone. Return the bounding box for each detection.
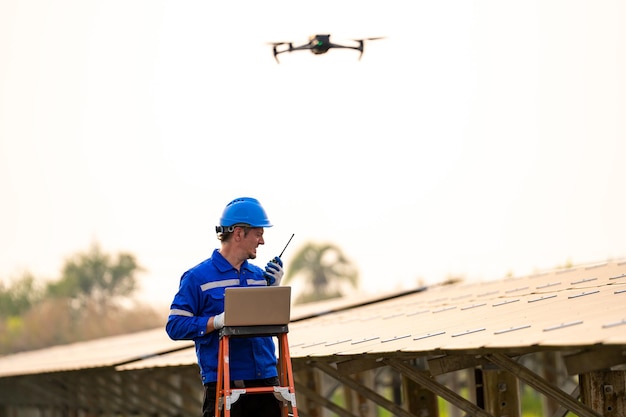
[0,0,626,304]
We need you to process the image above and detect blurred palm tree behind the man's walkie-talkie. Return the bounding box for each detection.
[283,243,358,304]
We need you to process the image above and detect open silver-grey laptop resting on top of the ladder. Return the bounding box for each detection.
[224,286,291,326]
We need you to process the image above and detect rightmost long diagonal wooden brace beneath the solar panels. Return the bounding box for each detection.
[485,353,602,417]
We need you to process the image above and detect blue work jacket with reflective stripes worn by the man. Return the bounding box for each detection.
[165,249,277,384]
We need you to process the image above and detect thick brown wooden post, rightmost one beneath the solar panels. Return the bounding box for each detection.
[578,371,626,417]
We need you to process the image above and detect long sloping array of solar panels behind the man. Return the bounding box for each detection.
[0,262,626,378]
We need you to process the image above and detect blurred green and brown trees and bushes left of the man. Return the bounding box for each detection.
[0,240,164,355]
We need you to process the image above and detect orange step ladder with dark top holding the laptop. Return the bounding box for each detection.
[215,324,298,417]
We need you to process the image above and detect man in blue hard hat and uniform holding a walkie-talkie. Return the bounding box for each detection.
[166,197,284,417]
